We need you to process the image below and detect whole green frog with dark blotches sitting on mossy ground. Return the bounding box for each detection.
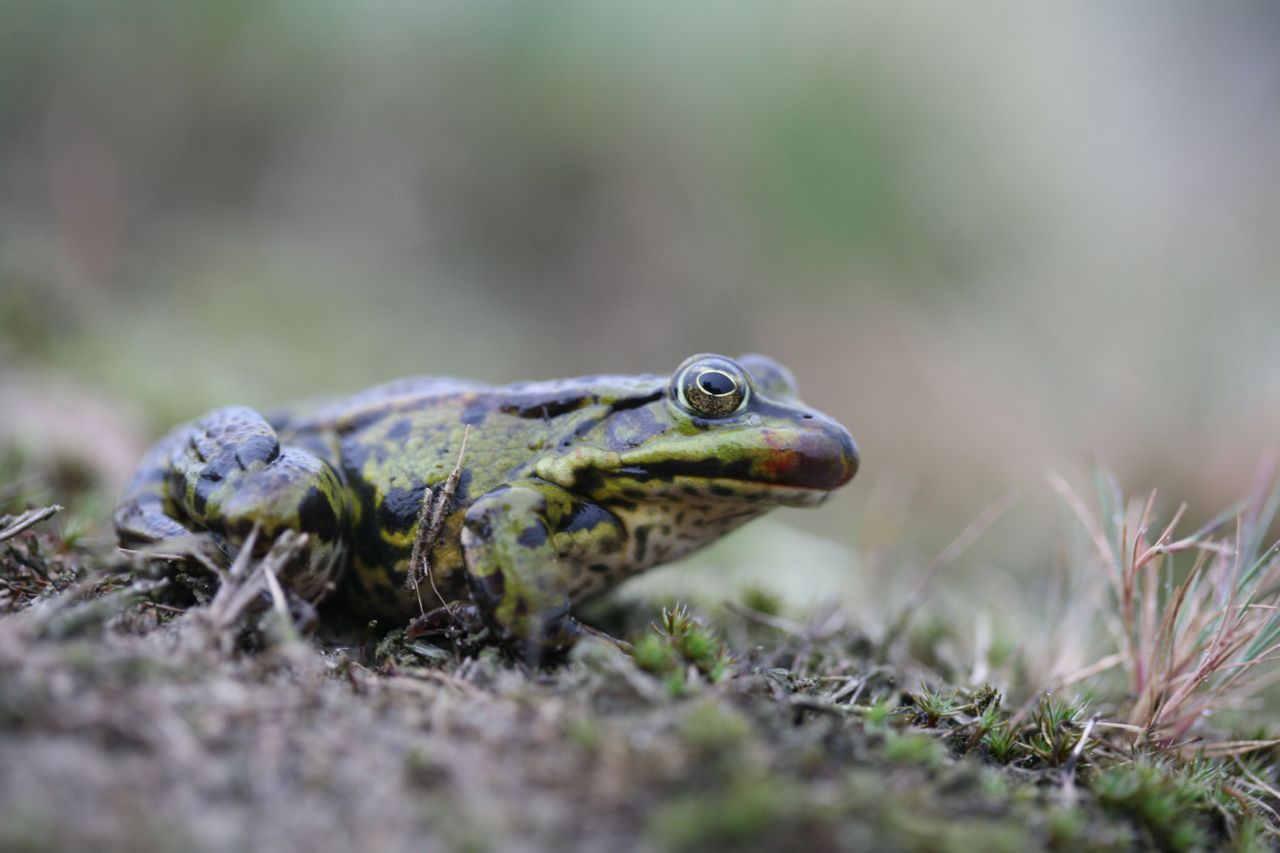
[114,353,859,656]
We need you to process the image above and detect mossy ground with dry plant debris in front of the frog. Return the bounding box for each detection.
[0,448,1275,852]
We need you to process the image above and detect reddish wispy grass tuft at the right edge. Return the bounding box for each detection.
[1050,469,1280,754]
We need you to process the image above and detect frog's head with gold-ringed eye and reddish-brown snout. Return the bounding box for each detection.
[540,353,858,511]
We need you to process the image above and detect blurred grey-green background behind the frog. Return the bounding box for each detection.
[0,0,1280,630]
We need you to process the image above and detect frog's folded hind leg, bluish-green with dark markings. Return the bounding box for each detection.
[115,406,351,601]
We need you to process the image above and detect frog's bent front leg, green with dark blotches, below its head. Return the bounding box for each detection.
[462,480,621,660]
